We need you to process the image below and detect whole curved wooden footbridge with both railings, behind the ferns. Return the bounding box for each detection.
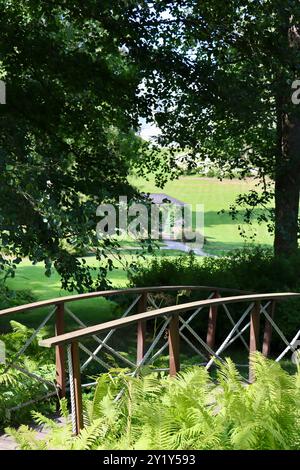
[0,286,300,434]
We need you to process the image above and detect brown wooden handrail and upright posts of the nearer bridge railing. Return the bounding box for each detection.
[39,291,300,433]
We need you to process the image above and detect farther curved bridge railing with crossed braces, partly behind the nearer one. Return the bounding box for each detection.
[0,285,246,414]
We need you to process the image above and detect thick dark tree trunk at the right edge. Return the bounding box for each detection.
[274,21,300,256]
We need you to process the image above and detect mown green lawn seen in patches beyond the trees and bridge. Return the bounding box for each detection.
[0,176,272,327]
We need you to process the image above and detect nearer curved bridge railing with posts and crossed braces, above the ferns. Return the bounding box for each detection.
[40,291,300,433]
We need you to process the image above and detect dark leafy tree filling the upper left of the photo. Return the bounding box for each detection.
[0,0,146,290]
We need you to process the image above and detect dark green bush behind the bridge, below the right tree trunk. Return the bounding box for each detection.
[130,248,300,347]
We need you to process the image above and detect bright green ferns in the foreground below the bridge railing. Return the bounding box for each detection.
[8,354,300,450]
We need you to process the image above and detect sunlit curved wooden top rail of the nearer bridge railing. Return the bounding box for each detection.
[39,294,300,348]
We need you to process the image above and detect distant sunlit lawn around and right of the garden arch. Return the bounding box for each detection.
[130,176,272,255]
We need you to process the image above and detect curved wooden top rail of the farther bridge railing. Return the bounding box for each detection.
[0,286,249,317]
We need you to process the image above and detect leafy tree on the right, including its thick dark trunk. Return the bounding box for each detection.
[128,0,300,254]
